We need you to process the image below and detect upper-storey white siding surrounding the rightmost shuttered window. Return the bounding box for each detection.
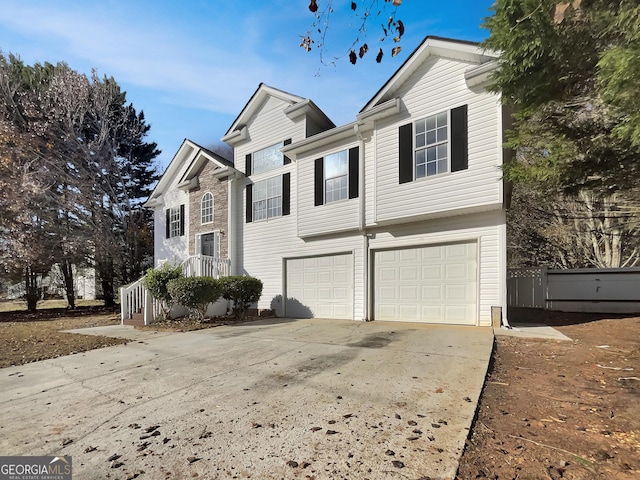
[374,58,502,222]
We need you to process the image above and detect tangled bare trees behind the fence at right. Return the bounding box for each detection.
[507,184,640,268]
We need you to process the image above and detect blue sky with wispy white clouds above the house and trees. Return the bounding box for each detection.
[0,0,493,172]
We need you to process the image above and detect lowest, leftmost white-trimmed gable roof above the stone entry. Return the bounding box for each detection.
[144,138,243,207]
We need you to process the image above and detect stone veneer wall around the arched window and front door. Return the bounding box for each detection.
[189,162,229,258]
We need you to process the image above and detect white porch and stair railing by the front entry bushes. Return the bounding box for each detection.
[120,255,231,325]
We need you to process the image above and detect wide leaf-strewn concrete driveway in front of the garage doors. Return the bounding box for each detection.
[0,319,493,479]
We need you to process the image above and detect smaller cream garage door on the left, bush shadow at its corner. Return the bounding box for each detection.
[285,254,353,320]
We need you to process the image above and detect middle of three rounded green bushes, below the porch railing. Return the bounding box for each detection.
[167,277,221,321]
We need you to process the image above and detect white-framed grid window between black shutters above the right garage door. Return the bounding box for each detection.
[415,112,449,178]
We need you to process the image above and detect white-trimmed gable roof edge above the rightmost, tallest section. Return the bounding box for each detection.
[360,36,498,114]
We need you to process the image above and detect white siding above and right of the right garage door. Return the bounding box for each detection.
[370,211,505,326]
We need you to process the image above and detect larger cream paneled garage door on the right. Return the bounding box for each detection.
[373,242,477,325]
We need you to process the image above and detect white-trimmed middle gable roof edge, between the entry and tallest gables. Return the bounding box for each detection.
[222,83,335,144]
